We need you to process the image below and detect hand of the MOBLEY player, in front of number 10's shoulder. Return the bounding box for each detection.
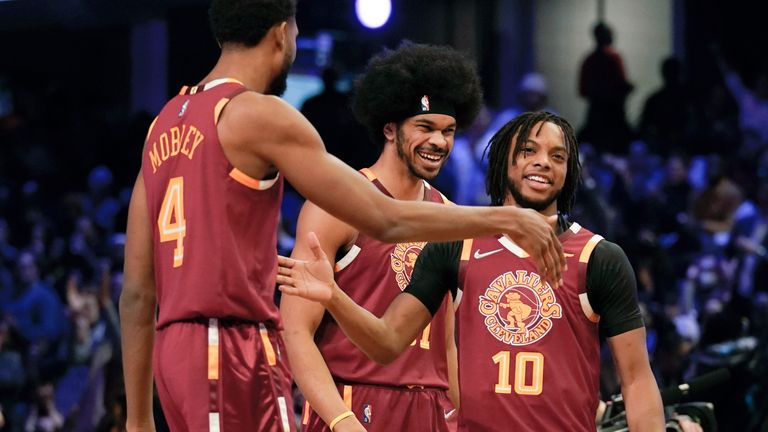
[507,207,566,288]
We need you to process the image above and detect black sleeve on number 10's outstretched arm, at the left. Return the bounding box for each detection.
[403,241,463,315]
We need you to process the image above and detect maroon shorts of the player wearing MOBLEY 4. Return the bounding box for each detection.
[153,319,296,432]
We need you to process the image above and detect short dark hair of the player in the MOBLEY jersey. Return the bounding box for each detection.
[208,0,296,47]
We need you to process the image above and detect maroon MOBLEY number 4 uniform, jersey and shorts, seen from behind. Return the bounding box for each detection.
[142,79,296,431]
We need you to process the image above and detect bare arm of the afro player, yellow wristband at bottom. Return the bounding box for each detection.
[280,201,365,432]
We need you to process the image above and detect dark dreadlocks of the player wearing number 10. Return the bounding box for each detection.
[485,111,581,214]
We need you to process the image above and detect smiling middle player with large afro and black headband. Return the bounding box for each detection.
[280,44,482,432]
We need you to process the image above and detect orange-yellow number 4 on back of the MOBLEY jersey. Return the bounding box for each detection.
[157,177,187,267]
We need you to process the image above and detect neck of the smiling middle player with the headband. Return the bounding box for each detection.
[370,144,424,201]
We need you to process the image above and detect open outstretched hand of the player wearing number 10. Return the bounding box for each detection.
[277,232,334,304]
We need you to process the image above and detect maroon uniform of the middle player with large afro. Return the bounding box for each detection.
[302,169,452,432]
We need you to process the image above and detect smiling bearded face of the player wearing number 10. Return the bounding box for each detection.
[505,122,568,215]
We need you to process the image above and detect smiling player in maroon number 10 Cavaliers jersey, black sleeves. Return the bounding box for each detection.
[278,112,664,432]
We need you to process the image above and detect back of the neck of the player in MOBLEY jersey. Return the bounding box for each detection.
[200,46,273,93]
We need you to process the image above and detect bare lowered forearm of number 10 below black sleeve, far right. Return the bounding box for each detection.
[608,327,665,432]
